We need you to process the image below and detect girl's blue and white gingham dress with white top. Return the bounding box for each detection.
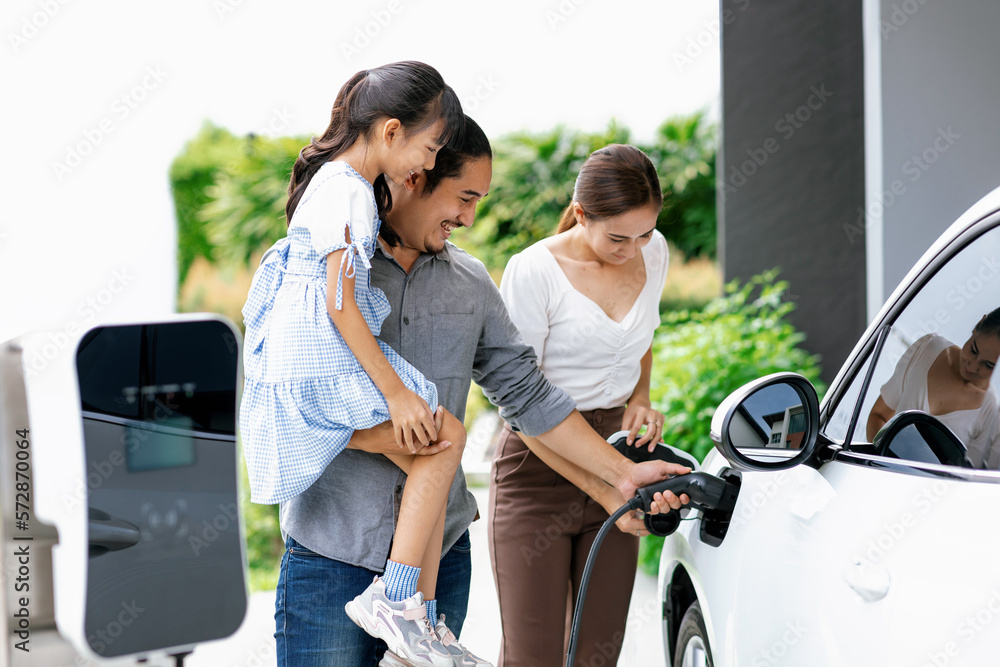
[240,162,437,504]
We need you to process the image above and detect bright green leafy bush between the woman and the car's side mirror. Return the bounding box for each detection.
[640,270,825,573]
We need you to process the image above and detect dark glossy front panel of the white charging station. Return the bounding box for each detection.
[77,320,246,658]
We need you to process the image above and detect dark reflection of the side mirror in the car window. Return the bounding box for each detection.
[874,410,974,468]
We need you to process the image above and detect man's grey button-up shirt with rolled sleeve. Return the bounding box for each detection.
[281,244,576,572]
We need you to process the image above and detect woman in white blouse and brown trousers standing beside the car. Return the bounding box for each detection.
[489,144,669,667]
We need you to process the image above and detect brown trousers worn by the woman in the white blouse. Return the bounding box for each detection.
[487,408,639,667]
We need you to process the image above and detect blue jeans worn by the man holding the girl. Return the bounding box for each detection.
[274,531,472,667]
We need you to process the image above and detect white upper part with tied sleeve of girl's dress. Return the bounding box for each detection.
[290,172,378,310]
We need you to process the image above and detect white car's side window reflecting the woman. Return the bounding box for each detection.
[826,222,1000,468]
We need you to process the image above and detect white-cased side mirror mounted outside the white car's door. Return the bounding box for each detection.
[711,373,819,471]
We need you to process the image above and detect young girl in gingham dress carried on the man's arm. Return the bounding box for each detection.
[240,62,488,667]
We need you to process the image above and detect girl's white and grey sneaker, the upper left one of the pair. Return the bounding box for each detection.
[344,577,455,667]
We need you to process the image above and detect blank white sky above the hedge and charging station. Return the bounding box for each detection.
[0,0,719,341]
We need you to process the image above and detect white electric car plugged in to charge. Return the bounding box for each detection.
[659,189,1000,667]
